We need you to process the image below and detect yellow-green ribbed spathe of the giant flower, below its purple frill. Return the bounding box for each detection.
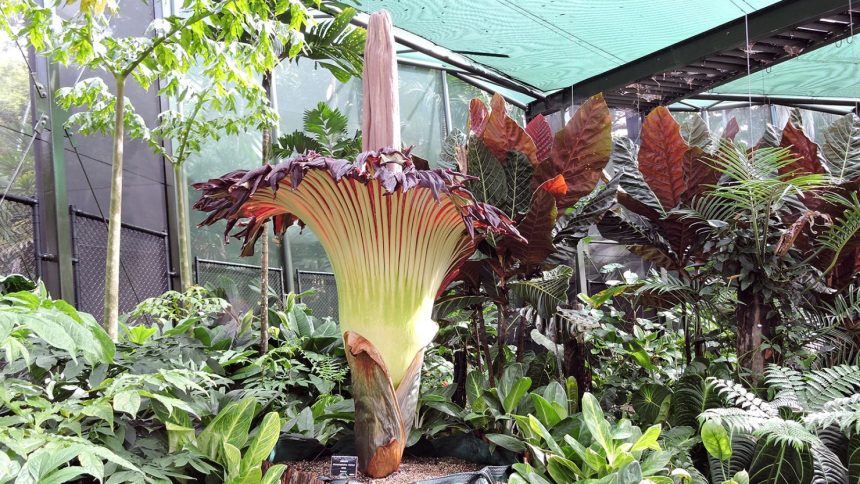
[246,170,473,388]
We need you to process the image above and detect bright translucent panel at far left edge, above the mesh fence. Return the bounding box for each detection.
[0,33,36,197]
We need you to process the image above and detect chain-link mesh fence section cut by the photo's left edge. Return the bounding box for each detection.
[0,195,40,280]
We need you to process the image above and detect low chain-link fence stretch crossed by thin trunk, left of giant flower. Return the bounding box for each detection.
[194,258,284,314]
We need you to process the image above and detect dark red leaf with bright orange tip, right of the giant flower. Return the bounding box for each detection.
[499,175,568,267]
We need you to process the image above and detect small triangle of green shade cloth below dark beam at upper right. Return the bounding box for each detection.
[711,35,860,98]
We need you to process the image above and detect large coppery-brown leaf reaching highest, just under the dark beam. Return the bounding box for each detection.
[534,94,612,209]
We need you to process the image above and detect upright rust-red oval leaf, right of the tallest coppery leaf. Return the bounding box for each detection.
[639,106,688,210]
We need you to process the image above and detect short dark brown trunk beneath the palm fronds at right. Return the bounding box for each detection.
[736,290,774,385]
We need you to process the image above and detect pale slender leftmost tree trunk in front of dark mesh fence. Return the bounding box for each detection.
[103,76,125,341]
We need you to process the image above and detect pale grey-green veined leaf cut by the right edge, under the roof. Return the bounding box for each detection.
[821,113,860,184]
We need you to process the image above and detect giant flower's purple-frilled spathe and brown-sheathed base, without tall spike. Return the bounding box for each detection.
[195,149,520,477]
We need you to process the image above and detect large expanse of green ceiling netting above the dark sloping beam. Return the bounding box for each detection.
[346,0,780,91]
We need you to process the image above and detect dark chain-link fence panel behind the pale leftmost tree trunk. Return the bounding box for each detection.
[71,210,170,319]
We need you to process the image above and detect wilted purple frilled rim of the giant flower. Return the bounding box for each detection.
[193,148,524,255]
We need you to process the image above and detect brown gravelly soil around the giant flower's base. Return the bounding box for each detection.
[282,456,484,484]
